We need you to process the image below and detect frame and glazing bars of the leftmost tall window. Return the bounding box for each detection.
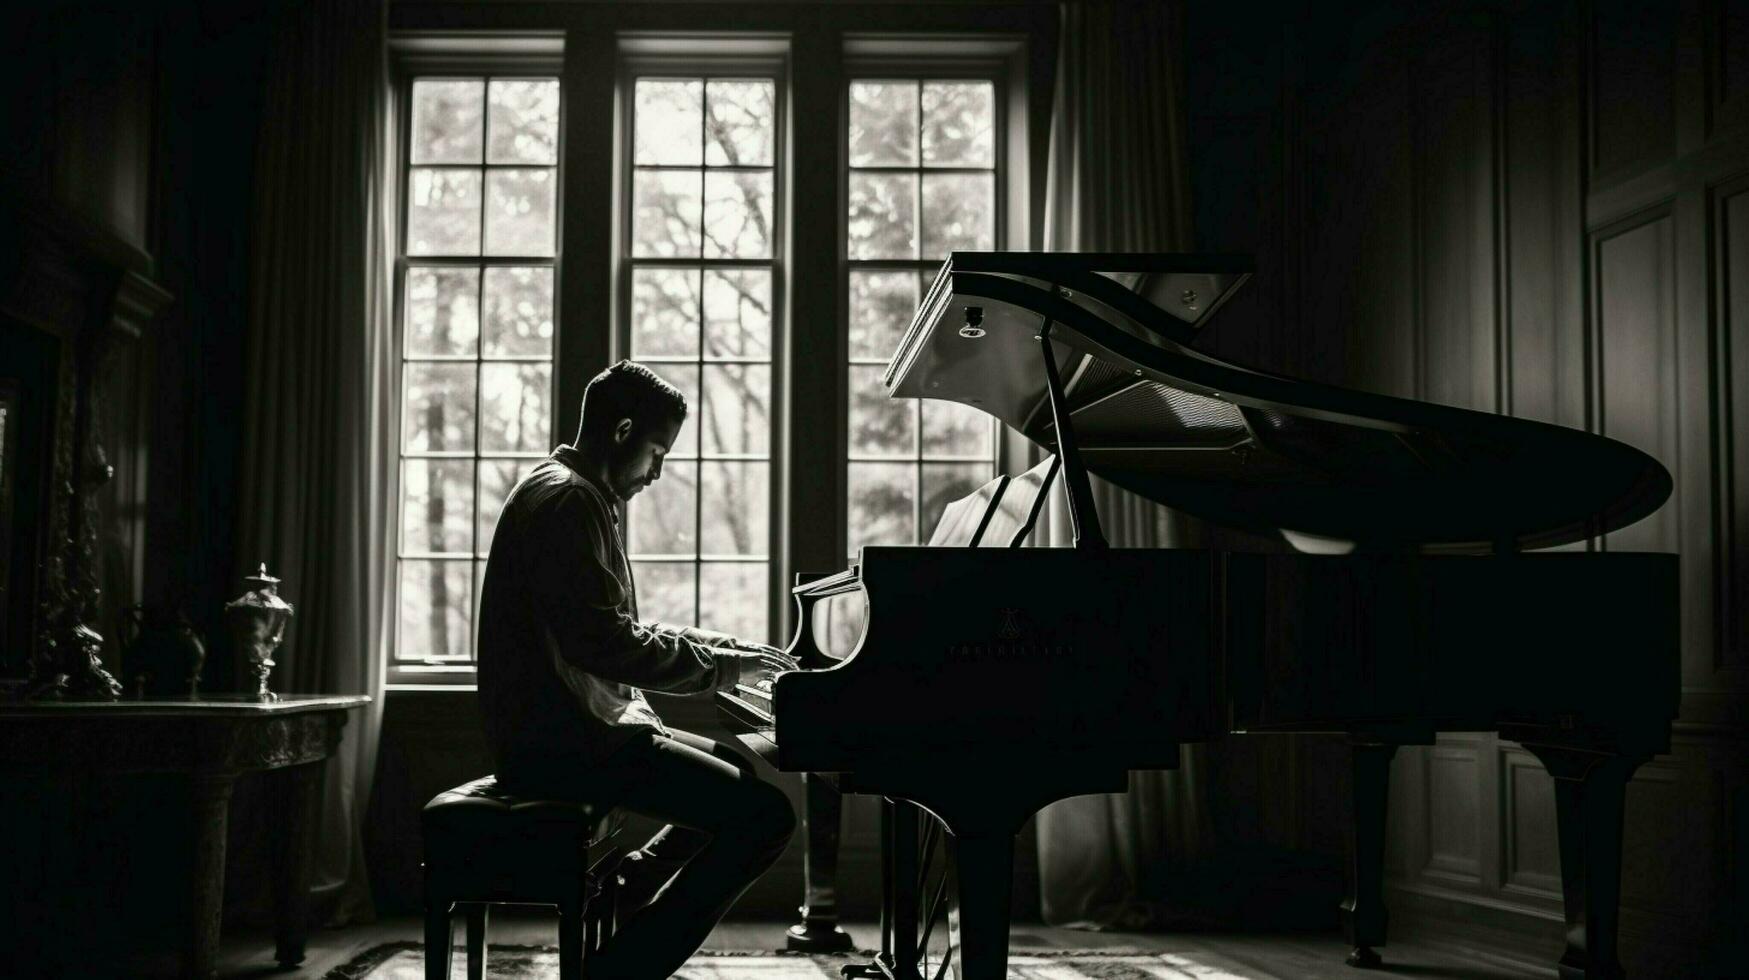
[383,32,568,690]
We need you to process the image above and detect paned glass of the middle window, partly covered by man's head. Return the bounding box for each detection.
[621,65,784,641]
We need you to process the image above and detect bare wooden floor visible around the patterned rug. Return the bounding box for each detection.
[219,910,1555,980]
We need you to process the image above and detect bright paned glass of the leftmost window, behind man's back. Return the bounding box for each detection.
[395,75,560,670]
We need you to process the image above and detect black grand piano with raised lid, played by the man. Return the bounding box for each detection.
[719,252,1679,980]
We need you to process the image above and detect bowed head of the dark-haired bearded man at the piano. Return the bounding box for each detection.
[577,361,686,499]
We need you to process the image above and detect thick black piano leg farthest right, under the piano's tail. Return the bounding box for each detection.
[1525,744,1646,980]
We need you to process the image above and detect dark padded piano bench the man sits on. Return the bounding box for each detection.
[420,775,621,980]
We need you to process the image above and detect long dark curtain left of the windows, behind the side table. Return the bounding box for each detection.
[238,0,397,922]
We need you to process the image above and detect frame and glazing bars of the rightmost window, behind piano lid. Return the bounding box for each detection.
[834,42,1028,562]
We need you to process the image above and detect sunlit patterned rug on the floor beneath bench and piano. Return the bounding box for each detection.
[324,943,1247,980]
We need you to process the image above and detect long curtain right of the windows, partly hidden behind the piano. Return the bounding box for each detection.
[1035,0,1214,929]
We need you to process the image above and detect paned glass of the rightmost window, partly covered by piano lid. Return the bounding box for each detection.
[845,75,1002,555]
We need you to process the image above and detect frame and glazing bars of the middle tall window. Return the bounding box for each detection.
[612,43,792,642]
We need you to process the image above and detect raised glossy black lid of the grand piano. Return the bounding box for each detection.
[885,252,1670,551]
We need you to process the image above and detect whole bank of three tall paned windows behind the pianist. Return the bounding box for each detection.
[385,24,1028,688]
